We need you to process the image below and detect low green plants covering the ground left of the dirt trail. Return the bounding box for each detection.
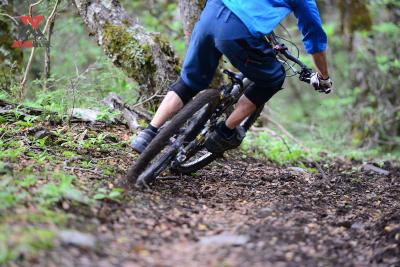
[0,113,131,266]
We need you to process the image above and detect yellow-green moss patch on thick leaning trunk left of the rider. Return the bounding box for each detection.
[103,22,156,87]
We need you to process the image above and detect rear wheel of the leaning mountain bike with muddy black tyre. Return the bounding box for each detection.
[127,89,220,186]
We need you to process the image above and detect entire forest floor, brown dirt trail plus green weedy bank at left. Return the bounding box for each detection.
[0,114,400,267]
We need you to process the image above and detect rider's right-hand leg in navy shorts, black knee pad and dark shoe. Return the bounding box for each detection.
[206,36,285,153]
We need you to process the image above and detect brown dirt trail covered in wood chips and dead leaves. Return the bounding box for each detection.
[5,123,400,267]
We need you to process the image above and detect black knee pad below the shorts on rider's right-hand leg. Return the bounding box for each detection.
[244,79,284,107]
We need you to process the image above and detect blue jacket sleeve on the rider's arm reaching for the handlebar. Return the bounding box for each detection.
[292,0,327,54]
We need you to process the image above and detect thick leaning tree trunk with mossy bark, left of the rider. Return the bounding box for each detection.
[73,0,179,97]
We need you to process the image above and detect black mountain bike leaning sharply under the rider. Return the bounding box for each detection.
[126,33,328,188]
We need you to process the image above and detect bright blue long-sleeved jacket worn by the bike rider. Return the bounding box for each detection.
[223,0,327,54]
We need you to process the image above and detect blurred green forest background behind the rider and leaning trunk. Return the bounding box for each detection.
[0,0,400,163]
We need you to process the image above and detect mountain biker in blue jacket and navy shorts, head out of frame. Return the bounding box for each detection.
[132,0,332,153]
